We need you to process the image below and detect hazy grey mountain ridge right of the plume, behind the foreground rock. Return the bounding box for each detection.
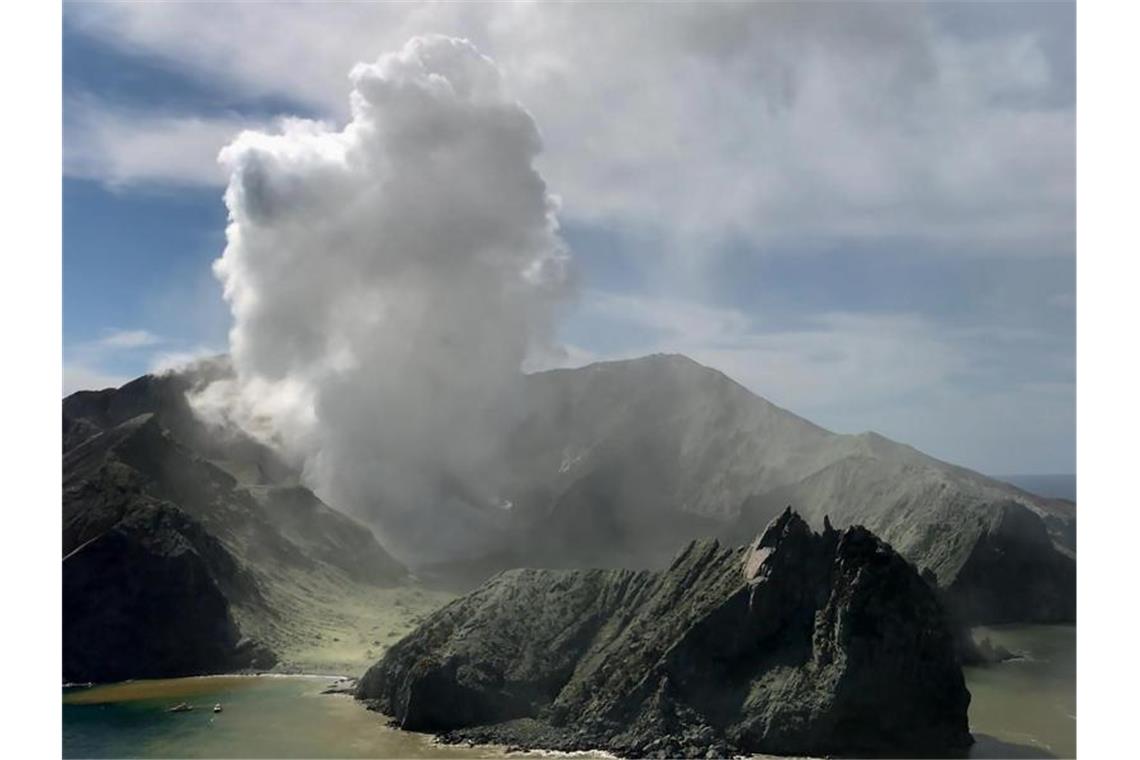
[485,356,1076,622]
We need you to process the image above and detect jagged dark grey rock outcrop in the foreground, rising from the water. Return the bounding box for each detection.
[357,510,972,757]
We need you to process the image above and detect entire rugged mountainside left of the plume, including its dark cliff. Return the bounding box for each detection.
[63,365,406,681]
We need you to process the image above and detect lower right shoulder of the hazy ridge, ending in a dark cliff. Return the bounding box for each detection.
[740,442,1076,623]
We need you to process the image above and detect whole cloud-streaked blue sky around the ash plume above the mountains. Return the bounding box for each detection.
[63,3,1075,473]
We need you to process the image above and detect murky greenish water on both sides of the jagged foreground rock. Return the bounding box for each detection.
[63,626,1076,758]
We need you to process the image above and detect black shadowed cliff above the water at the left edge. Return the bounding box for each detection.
[63,501,276,683]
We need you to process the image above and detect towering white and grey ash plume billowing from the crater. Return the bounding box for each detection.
[196,36,571,561]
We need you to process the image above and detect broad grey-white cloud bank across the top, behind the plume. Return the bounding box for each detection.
[68,3,1075,260]
